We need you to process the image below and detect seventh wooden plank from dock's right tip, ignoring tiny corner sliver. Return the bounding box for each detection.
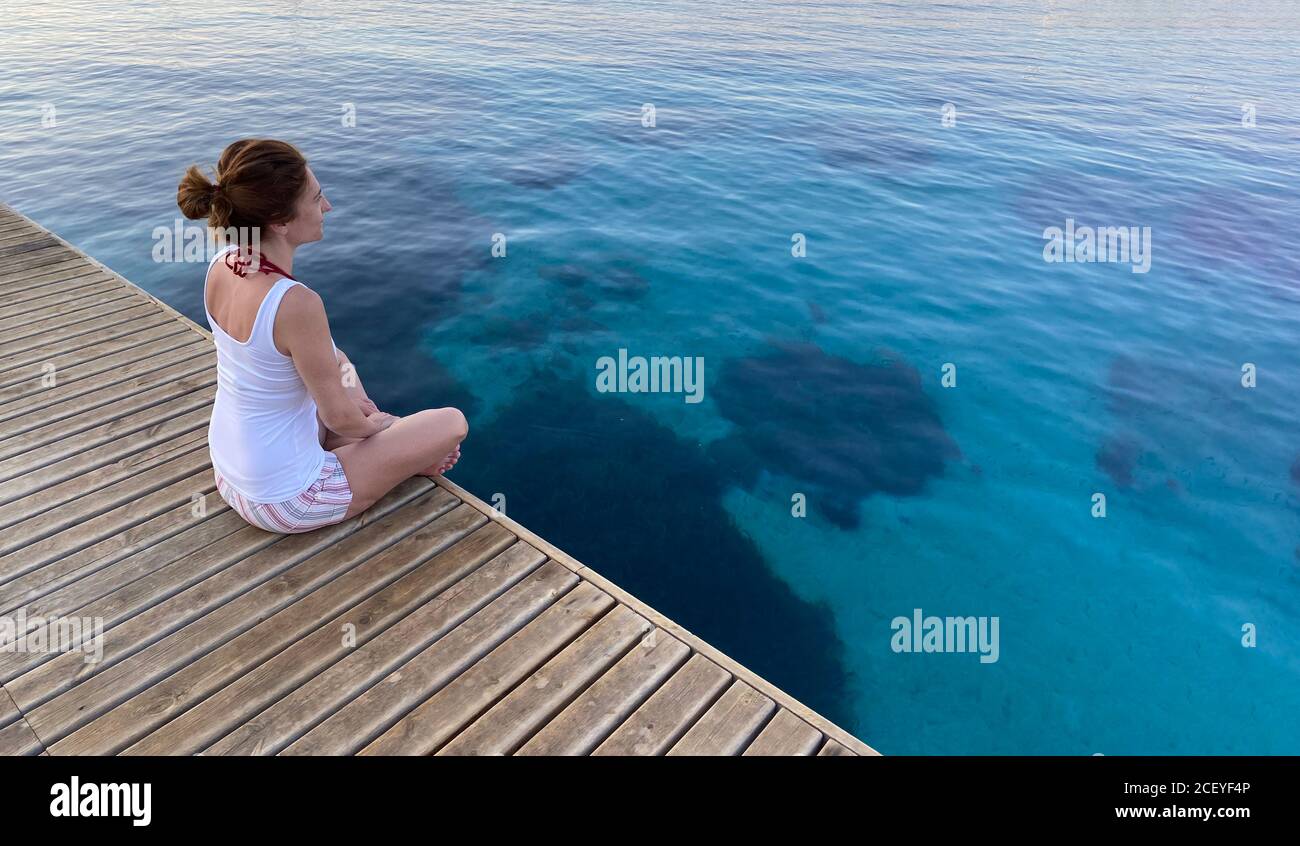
[280,563,589,755]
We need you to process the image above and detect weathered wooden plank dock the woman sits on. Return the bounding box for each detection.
[0,205,875,755]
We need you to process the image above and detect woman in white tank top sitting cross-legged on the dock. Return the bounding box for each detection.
[177,139,468,533]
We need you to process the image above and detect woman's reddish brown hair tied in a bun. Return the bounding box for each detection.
[176,138,307,229]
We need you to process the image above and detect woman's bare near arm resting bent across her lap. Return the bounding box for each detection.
[277,285,395,438]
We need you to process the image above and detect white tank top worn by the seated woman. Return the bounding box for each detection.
[203,244,338,503]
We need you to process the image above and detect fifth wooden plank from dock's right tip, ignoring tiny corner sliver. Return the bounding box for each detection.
[437,606,650,755]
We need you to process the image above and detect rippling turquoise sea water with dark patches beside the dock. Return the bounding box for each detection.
[0,0,1300,755]
